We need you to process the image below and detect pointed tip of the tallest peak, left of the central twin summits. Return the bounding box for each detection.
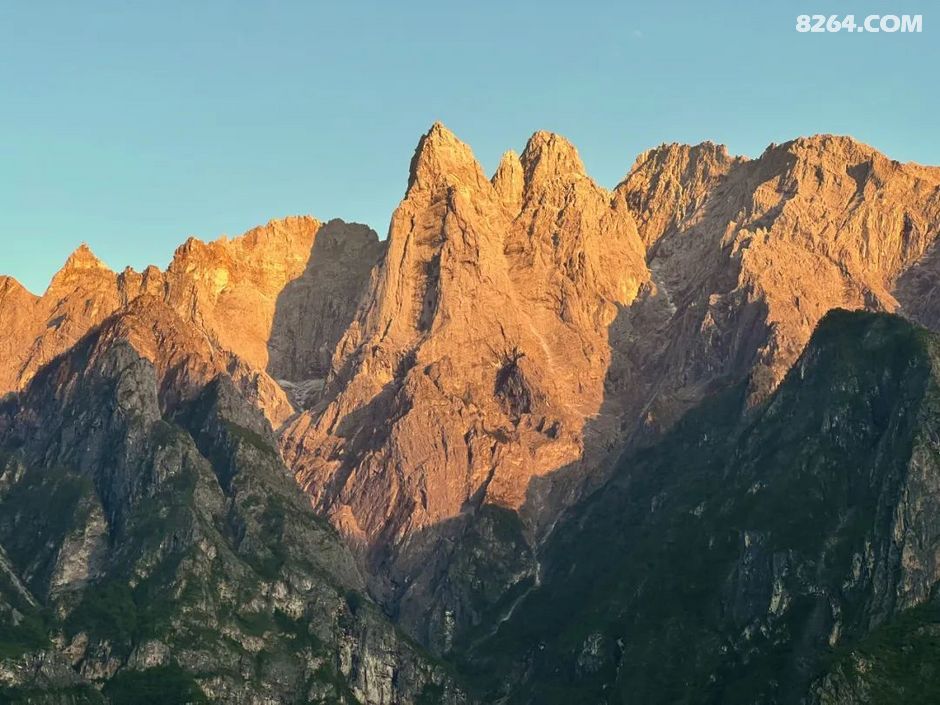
[408,121,486,192]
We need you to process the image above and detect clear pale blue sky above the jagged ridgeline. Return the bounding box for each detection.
[0,0,940,292]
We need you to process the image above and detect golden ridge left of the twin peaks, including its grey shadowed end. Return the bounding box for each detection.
[0,217,381,427]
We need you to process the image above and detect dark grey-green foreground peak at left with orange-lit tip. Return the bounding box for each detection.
[0,295,463,705]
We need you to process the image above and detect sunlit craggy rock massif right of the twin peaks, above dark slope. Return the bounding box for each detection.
[617,135,940,436]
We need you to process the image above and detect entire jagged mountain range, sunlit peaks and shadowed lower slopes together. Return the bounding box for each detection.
[0,123,940,705]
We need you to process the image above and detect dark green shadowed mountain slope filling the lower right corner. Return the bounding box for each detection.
[465,311,940,705]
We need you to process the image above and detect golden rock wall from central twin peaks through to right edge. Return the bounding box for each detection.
[282,125,940,650]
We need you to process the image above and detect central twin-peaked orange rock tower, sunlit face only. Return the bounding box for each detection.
[282,124,648,648]
